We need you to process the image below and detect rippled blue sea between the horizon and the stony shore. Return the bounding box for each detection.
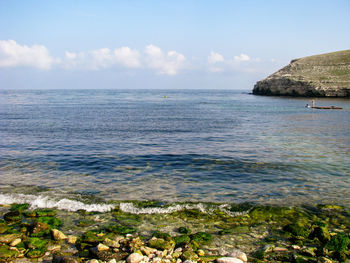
[0,90,350,205]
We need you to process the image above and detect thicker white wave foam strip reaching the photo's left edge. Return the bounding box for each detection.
[0,193,114,212]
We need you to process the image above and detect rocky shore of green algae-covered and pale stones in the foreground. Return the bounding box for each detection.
[0,201,350,263]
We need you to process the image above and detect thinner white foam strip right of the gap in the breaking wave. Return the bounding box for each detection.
[119,203,207,214]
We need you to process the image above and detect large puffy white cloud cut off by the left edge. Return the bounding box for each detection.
[0,40,58,69]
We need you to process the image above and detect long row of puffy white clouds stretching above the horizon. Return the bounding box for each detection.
[0,40,266,76]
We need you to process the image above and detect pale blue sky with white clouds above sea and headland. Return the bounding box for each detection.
[0,0,350,90]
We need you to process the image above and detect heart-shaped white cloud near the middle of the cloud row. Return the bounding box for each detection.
[145,45,186,75]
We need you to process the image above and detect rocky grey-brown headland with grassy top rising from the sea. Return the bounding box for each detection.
[253,50,350,97]
